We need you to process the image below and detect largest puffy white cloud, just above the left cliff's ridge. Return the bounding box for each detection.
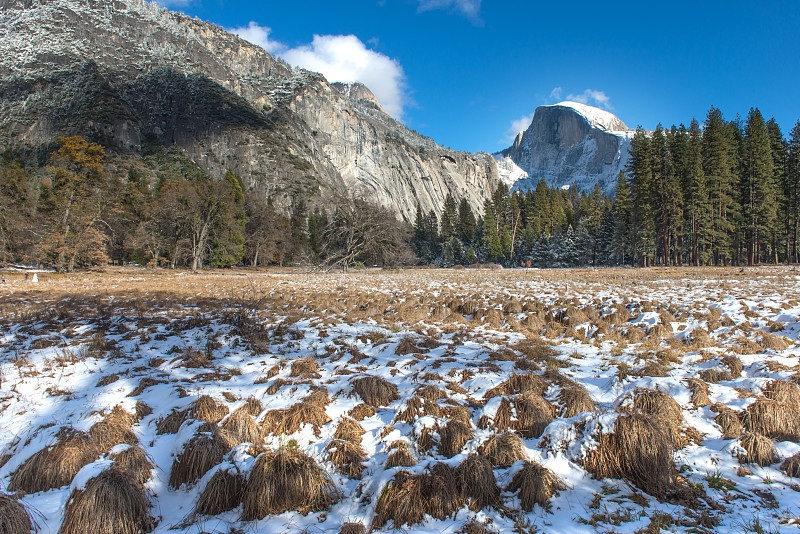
[229,22,408,119]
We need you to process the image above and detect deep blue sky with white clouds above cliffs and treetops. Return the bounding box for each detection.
[160,0,800,152]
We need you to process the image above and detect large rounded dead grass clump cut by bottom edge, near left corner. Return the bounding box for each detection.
[58,469,155,534]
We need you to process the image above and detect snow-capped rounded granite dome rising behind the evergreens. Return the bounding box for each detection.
[495,102,633,195]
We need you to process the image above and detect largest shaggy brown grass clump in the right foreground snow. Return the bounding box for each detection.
[584,414,675,495]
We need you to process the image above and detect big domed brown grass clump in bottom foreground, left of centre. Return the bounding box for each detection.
[242,447,340,521]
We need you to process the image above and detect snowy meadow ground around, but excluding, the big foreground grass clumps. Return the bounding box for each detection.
[0,267,800,533]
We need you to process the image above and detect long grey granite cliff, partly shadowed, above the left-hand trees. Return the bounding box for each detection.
[0,0,499,220]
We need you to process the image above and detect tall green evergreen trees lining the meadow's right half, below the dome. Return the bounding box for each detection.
[414,107,800,267]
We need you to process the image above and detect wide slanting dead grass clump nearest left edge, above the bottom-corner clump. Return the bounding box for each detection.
[8,427,100,493]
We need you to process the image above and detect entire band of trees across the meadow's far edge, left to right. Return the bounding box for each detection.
[0,107,800,270]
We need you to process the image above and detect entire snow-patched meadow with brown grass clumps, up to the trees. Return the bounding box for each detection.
[0,267,800,534]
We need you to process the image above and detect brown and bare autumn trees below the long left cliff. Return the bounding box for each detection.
[0,136,413,271]
